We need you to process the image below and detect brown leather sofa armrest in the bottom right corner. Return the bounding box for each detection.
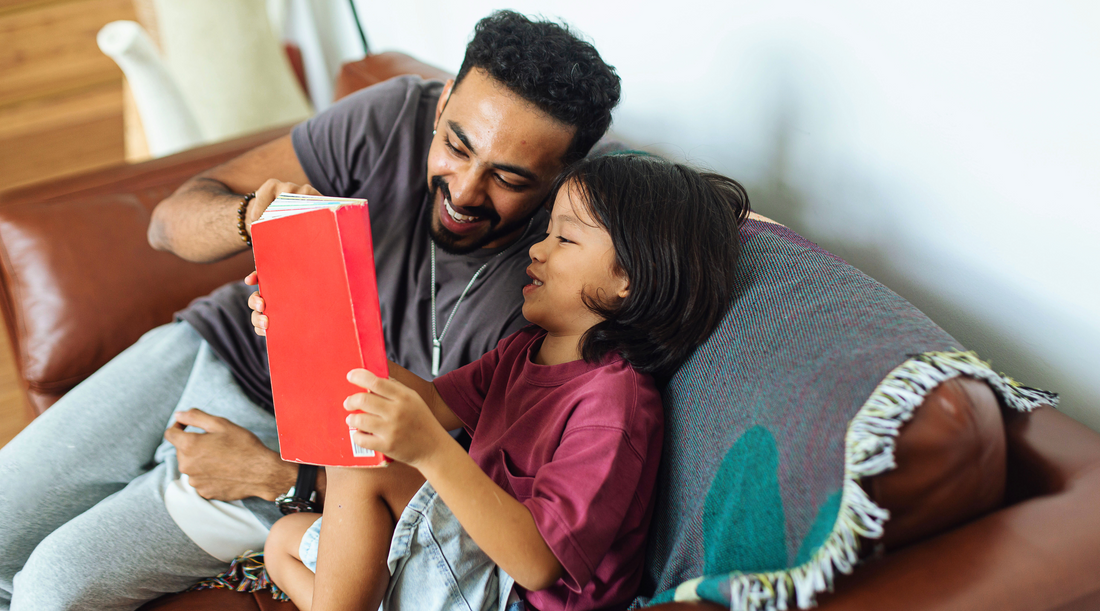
[820,407,1100,611]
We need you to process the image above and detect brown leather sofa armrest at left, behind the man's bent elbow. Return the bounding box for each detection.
[0,128,289,417]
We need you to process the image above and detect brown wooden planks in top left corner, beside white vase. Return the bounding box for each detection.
[0,0,134,188]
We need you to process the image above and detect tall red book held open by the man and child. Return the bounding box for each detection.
[252,194,391,467]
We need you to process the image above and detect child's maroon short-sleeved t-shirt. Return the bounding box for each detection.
[435,326,663,611]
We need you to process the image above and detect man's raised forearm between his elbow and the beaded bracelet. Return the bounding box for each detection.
[149,176,248,263]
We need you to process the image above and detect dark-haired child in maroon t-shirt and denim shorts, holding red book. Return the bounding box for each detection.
[265,154,748,611]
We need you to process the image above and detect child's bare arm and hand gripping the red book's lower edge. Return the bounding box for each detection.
[344,365,564,590]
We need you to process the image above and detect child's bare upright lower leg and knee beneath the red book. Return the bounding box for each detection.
[307,462,424,611]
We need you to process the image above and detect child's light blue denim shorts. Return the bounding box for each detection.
[298,482,525,611]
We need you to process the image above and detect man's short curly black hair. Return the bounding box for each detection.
[454,11,620,164]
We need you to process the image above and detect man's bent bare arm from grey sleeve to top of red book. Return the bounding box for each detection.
[149,135,315,263]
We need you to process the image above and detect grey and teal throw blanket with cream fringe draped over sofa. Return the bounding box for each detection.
[635,220,1056,610]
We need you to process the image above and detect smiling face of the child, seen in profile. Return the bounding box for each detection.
[524,183,629,336]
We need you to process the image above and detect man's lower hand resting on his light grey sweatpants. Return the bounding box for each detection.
[164,408,298,501]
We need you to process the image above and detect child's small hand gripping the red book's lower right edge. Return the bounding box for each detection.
[344,369,453,467]
